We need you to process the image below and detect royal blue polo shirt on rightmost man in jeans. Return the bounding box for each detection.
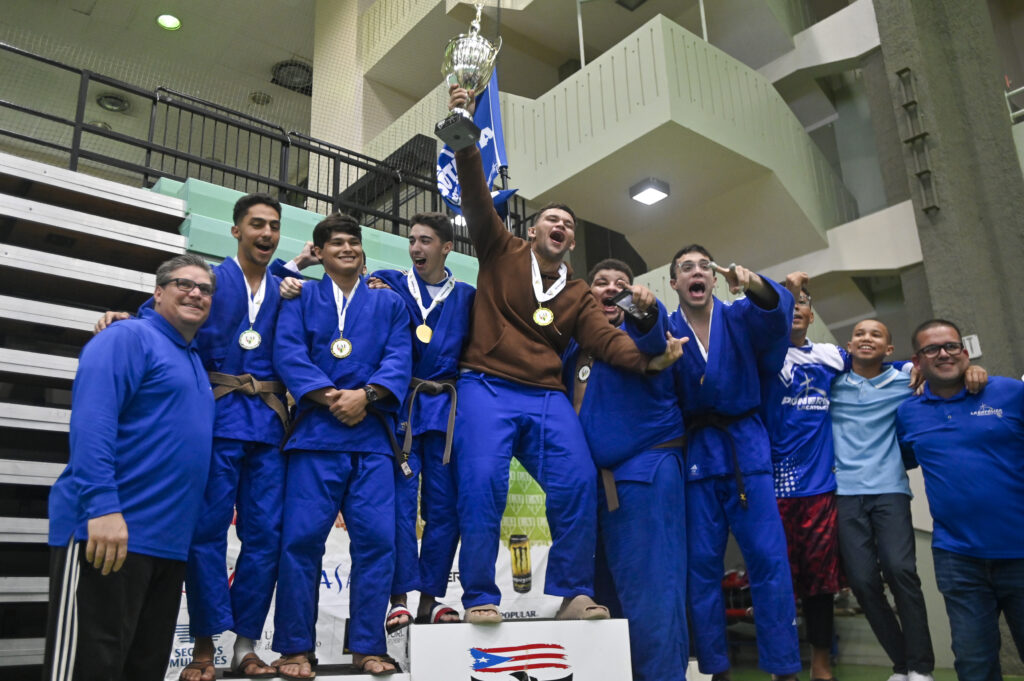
[897,376,1024,559]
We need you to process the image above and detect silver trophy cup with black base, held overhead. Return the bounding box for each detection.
[434,3,502,152]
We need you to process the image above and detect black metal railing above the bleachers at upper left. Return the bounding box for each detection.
[0,42,529,253]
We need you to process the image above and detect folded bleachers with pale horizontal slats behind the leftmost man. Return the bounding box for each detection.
[0,154,187,677]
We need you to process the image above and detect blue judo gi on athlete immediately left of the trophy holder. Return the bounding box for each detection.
[372,269,475,598]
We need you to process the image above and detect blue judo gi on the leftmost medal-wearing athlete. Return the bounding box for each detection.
[174,258,285,639]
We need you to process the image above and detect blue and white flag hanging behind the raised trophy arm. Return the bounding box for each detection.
[437,69,517,219]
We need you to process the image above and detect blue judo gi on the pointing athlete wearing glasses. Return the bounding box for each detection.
[669,278,801,675]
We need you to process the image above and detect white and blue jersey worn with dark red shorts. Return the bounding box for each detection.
[761,341,850,499]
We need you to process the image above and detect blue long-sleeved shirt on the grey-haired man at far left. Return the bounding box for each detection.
[49,309,214,560]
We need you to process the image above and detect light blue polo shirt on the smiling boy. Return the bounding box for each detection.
[831,367,911,496]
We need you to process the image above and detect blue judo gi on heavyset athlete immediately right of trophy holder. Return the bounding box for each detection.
[562,303,689,681]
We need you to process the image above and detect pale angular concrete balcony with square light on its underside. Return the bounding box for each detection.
[371,16,857,267]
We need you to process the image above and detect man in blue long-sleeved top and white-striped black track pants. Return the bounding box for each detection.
[44,254,216,681]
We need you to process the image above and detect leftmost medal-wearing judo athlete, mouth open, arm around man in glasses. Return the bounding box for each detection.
[96,194,316,681]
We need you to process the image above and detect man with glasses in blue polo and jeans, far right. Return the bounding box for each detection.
[896,320,1024,681]
